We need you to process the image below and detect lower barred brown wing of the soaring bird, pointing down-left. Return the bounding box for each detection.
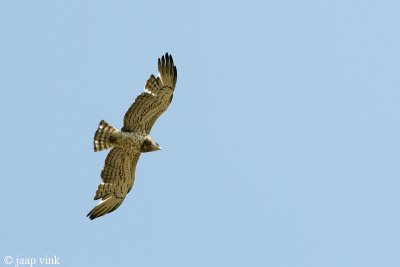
[87,148,140,220]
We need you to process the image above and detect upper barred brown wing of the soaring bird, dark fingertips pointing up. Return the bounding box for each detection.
[121,53,178,134]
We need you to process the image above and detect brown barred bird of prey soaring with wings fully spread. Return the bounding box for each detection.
[87,53,177,220]
